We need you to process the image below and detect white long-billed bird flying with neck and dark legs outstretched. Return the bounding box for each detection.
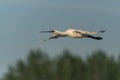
[40,29,105,41]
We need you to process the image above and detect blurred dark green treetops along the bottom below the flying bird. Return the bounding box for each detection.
[2,50,120,80]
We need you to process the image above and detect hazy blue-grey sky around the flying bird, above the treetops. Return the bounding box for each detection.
[0,0,120,76]
